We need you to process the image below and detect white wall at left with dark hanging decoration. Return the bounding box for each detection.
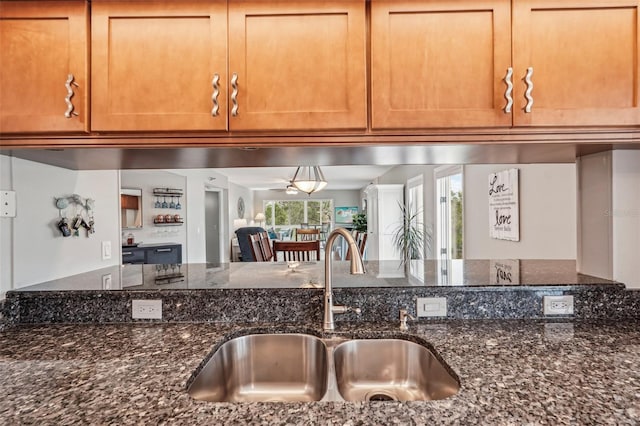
[7,158,120,288]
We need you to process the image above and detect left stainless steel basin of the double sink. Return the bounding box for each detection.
[189,334,328,402]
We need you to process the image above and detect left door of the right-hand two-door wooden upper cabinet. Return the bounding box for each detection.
[371,0,512,129]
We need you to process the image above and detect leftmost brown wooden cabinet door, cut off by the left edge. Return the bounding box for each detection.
[0,1,89,133]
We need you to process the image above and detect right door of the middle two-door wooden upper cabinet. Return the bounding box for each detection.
[229,0,367,130]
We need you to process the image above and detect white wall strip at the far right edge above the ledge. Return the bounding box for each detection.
[608,150,640,288]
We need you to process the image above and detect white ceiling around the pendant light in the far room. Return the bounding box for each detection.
[215,166,393,191]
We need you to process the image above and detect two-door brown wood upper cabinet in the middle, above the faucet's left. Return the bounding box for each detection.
[92,0,367,131]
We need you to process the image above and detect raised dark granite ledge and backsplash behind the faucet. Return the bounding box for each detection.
[4,260,640,324]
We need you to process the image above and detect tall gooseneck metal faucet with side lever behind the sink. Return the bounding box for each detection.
[323,228,365,331]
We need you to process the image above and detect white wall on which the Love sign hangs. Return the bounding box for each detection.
[463,164,577,259]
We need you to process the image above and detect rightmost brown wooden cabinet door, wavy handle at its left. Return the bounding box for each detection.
[513,0,640,126]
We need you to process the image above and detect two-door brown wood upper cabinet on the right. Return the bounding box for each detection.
[371,0,640,129]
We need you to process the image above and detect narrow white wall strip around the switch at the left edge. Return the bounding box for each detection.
[0,155,14,299]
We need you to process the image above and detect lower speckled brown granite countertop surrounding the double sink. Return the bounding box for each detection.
[0,320,640,425]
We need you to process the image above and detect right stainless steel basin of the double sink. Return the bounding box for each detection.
[334,339,460,401]
